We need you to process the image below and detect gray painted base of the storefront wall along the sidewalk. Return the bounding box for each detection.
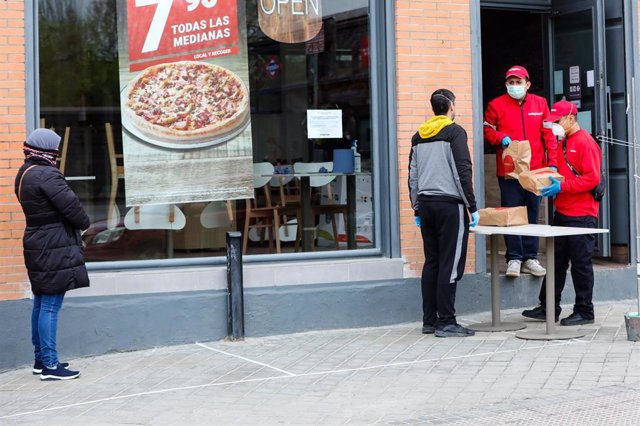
[0,267,635,372]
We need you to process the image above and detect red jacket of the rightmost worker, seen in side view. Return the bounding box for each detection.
[553,129,602,217]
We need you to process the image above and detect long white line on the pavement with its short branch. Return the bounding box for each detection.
[0,340,583,419]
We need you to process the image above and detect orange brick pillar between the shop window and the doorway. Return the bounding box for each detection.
[396,0,475,276]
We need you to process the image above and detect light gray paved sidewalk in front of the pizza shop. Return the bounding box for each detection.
[0,301,640,426]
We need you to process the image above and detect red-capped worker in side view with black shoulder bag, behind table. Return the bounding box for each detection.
[522,101,602,325]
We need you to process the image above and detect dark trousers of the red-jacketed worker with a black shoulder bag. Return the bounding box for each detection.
[540,212,597,319]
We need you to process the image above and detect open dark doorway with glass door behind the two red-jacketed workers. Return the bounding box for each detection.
[480,0,632,263]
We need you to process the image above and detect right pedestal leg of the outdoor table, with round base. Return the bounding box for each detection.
[516,237,586,340]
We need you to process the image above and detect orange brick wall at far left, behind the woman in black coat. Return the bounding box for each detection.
[0,0,29,300]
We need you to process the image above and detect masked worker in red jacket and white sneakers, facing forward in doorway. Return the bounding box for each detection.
[484,65,557,278]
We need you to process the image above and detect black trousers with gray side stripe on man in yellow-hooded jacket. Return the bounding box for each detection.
[418,198,469,327]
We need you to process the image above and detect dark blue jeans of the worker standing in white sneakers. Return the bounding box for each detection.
[498,177,540,262]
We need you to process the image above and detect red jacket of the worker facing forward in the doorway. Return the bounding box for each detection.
[484,93,557,176]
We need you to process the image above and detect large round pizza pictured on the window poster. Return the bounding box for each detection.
[122,61,249,144]
